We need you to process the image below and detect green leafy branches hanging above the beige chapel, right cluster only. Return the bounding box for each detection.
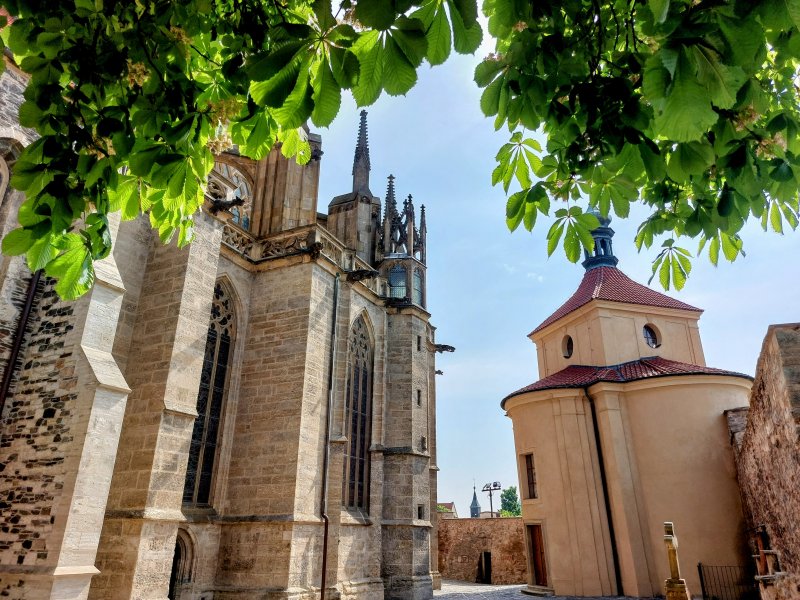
[484,0,800,288]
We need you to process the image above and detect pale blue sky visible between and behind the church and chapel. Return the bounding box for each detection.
[315,45,800,516]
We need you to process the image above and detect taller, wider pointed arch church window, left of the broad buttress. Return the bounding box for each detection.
[183,282,235,507]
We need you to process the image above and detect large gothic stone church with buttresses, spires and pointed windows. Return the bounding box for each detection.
[0,57,438,600]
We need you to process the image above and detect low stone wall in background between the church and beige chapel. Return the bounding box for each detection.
[439,517,528,584]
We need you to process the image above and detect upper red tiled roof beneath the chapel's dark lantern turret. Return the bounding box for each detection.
[531,267,703,333]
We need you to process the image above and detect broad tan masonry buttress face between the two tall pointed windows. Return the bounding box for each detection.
[216,259,313,598]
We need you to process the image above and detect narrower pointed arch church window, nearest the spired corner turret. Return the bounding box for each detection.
[342,317,375,511]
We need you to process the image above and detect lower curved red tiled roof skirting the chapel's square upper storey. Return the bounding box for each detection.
[500,356,752,407]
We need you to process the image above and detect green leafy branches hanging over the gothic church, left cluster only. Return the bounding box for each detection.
[2,0,482,298]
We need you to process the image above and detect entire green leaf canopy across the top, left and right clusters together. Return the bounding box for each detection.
[2,0,800,298]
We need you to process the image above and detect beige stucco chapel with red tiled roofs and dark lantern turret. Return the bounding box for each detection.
[502,219,751,597]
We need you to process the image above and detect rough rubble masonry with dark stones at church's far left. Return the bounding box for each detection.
[0,281,78,565]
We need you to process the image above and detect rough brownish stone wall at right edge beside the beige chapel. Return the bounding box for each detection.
[728,323,800,600]
